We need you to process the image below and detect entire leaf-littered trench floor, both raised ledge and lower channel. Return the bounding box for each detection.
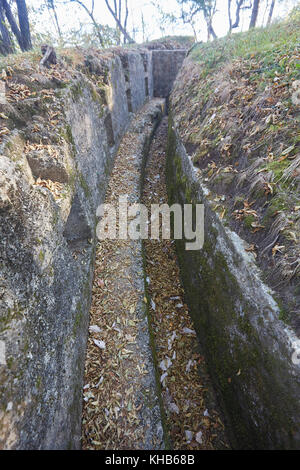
[82,107,229,450]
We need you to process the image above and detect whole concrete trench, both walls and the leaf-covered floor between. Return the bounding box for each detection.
[0,45,300,450]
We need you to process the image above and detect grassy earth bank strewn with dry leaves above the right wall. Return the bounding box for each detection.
[172,11,300,332]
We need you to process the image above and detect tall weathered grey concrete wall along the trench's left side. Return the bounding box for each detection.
[0,50,183,449]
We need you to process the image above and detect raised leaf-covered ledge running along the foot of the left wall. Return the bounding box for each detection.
[82,100,163,450]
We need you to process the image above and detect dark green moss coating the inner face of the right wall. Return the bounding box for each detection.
[166,111,295,449]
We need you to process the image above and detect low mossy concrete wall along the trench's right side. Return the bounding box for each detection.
[167,116,300,449]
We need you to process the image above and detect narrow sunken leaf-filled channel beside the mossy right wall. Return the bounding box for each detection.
[143,118,227,450]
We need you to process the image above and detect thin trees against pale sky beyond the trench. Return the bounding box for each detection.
[0,0,298,55]
